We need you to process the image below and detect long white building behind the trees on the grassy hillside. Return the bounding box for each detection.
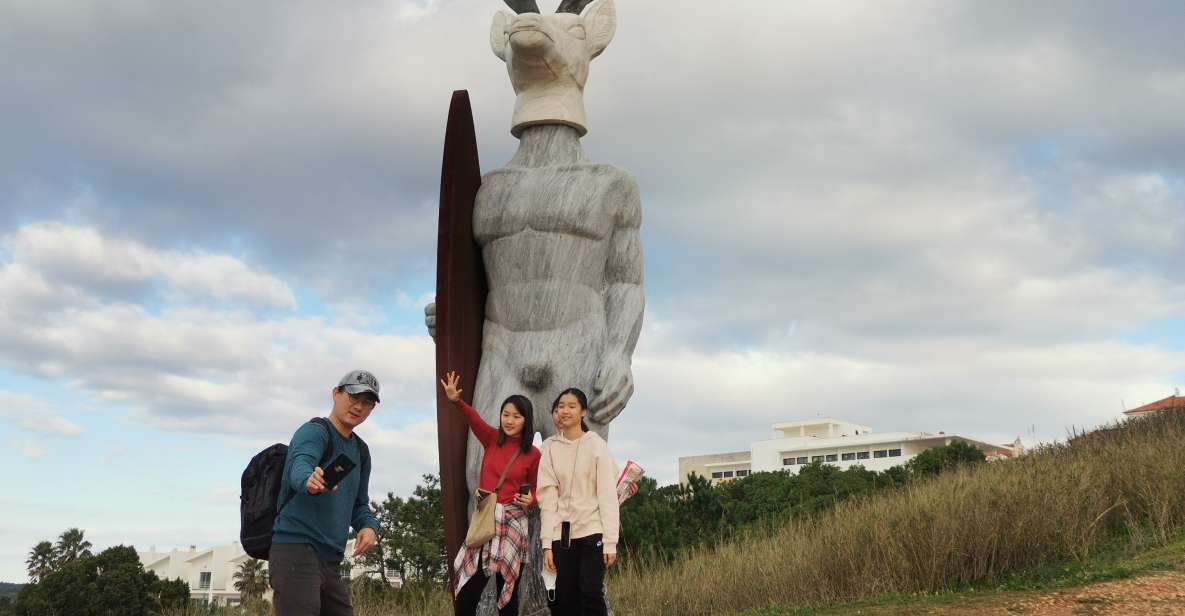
[679,418,1024,482]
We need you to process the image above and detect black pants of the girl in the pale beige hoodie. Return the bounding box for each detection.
[547,534,608,616]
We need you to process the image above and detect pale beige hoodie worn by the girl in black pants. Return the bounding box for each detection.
[537,431,619,554]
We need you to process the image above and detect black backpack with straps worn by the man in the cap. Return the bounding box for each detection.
[238,417,370,560]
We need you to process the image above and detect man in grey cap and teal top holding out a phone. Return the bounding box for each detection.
[268,370,378,616]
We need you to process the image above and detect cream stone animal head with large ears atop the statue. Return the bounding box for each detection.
[489,0,617,137]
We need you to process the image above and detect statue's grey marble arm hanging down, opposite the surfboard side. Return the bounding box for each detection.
[590,175,646,423]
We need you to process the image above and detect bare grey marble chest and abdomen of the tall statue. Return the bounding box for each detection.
[473,162,633,332]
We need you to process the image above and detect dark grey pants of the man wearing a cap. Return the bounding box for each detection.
[268,544,354,616]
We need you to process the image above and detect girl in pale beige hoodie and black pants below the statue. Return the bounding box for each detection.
[538,387,620,616]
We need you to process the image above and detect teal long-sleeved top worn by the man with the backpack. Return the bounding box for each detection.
[271,422,378,560]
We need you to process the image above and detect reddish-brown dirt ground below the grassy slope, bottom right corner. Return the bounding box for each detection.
[858,571,1185,616]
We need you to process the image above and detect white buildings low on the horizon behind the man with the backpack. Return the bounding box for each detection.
[136,540,398,605]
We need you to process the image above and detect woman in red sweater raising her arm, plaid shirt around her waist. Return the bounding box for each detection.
[441,372,539,616]
